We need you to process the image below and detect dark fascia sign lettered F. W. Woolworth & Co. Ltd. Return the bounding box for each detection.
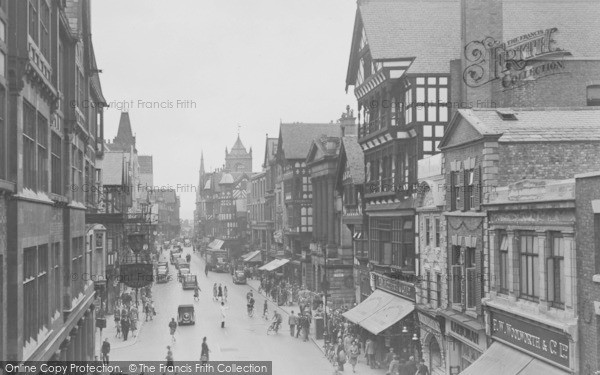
[491,311,570,367]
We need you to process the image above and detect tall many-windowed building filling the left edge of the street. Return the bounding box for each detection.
[0,0,106,361]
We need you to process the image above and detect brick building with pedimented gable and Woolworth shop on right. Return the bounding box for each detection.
[440,107,600,374]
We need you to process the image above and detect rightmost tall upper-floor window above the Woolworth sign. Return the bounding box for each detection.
[547,233,565,308]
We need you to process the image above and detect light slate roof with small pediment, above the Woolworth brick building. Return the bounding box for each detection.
[440,107,600,148]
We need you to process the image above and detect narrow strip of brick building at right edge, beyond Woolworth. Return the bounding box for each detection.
[575,172,600,375]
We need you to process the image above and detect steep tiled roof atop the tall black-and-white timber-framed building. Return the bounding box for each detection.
[346,0,462,86]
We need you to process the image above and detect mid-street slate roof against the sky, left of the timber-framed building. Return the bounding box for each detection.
[277,122,341,159]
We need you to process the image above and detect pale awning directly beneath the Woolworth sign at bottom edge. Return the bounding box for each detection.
[460,342,568,375]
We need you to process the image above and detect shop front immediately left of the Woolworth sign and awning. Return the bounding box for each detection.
[441,310,487,374]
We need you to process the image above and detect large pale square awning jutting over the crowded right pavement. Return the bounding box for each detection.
[343,289,415,335]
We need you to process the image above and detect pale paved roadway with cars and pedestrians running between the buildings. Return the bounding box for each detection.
[109,248,332,375]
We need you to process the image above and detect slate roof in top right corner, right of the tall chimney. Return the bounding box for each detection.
[502,0,600,59]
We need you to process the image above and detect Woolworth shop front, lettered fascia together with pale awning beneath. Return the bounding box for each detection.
[462,309,577,375]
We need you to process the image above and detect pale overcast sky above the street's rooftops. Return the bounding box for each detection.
[92,0,356,219]
